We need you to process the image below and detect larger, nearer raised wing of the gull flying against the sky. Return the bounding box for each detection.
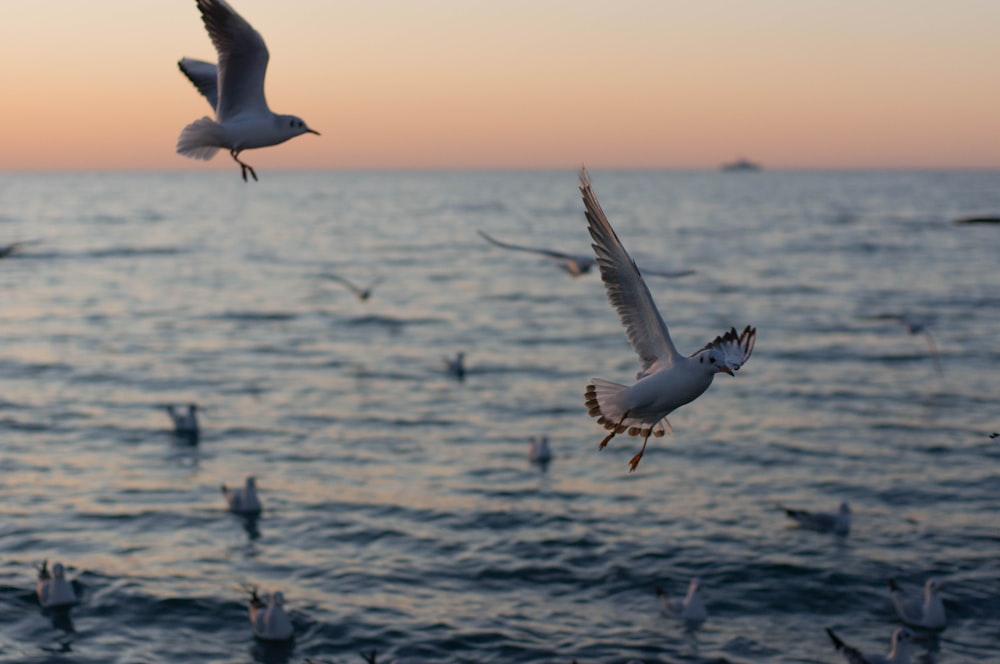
[198,0,270,122]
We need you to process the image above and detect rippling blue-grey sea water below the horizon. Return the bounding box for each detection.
[0,170,1000,664]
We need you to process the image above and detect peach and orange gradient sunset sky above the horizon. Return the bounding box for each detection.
[0,0,1000,170]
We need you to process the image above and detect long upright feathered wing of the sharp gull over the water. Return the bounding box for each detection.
[580,169,678,372]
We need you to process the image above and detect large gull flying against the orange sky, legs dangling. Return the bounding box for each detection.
[177,0,319,182]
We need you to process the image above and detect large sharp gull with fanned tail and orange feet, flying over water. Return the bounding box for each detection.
[580,168,757,471]
